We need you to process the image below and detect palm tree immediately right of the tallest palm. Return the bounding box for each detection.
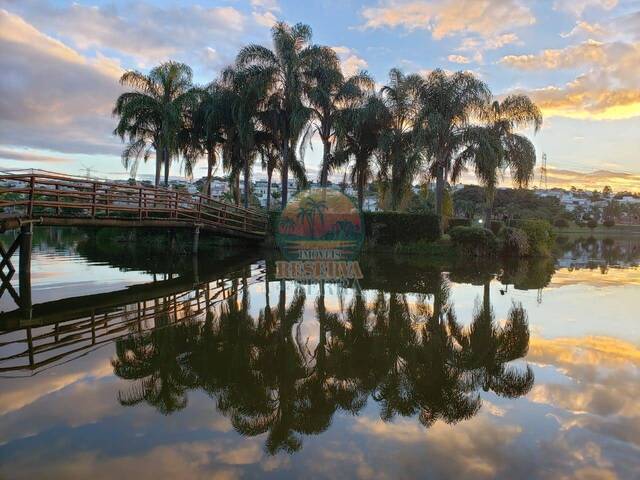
[302,61,374,187]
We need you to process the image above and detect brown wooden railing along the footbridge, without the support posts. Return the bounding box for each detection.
[0,172,267,238]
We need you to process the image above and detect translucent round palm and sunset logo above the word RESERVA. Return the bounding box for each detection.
[276,188,364,261]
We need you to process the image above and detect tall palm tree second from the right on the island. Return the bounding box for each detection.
[421,69,490,225]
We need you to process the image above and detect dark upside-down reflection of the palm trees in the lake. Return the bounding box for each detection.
[112,275,534,453]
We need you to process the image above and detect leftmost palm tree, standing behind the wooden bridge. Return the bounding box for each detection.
[113,62,196,186]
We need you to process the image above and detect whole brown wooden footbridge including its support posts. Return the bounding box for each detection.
[0,171,267,311]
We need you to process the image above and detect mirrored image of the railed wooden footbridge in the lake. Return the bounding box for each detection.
[0,265,265,376]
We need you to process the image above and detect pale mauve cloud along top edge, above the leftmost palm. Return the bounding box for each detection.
[3,1,247,67]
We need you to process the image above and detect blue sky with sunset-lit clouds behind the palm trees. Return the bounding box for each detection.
[0,0,640,191]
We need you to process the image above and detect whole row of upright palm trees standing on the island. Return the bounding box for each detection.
[114,23,542,225]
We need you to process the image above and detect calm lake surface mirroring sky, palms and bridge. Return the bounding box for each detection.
[0,229,640,479]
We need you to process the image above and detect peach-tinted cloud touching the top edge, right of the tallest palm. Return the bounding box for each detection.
[362,0,536,39]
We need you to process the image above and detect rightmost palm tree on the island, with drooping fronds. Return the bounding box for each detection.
[462,95,542,228]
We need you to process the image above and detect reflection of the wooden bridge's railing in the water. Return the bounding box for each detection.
[0,266,266,375]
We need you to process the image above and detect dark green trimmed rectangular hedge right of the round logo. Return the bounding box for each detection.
[362,212,440,246]
